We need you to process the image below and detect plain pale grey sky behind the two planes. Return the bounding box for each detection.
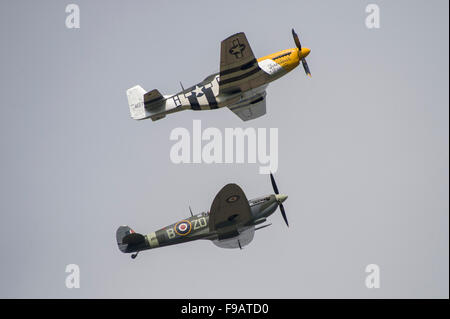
[0,0,449,298]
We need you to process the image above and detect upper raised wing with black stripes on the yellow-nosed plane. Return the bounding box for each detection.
[219,32,260,93]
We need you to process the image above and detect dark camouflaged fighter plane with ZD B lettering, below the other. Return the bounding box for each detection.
[116,174,289,259]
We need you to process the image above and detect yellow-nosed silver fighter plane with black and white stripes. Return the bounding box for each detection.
[127,29,311,121]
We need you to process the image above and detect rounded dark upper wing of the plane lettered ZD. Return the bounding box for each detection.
[209,184,252,233]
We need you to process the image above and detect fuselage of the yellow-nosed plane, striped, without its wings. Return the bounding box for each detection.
[127,48,310,121]
